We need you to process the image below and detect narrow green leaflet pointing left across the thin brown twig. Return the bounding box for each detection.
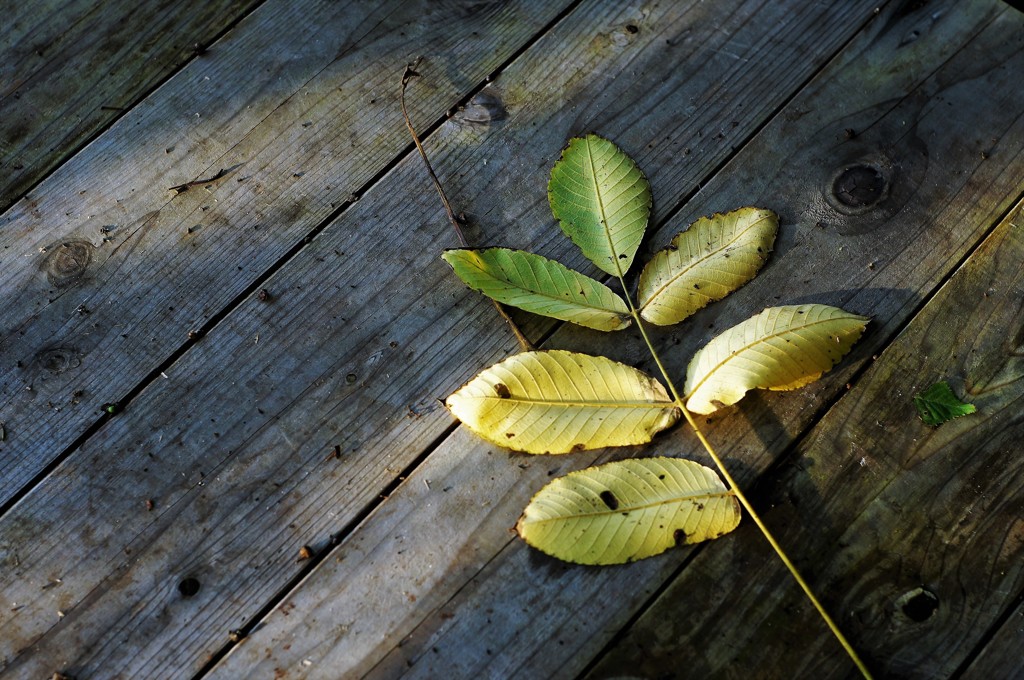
[441,248,631,331]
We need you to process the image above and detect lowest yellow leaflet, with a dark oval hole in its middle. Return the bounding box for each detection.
[516,458,740,564]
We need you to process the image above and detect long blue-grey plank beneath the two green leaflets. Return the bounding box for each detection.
[0,2,872,674]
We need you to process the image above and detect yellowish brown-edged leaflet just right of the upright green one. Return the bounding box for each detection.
[637,208,778,326]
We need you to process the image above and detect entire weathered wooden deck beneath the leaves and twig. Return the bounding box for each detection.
[0,0,1024,680]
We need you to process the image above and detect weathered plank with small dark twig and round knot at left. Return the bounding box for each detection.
[0,0,558,504]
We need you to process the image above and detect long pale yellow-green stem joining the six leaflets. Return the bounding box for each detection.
[618,269,871,680]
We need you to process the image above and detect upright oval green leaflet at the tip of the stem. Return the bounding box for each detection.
[548,134,651,277]
